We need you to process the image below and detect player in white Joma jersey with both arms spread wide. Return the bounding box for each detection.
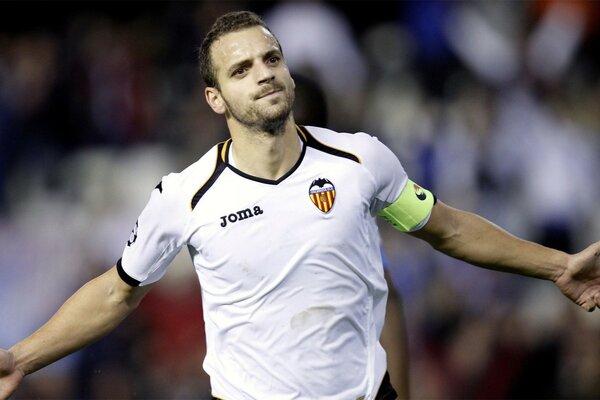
[0,12,600,399]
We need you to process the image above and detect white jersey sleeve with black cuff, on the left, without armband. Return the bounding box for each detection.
[117,174,187,286]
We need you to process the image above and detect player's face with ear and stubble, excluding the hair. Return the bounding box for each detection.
[205,26,294,133]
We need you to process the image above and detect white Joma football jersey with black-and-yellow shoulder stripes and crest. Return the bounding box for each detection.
[118,127,408,400]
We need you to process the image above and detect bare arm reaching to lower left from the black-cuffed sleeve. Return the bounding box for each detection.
[0,267,149,399]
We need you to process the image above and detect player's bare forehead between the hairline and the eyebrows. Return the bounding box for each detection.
[211,26,279,69]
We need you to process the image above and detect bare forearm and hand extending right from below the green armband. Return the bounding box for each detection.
[411,201,600,311]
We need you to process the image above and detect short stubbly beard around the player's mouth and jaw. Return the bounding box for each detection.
[223,86,295,136]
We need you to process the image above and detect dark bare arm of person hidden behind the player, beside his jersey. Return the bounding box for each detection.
[380,273,410,399]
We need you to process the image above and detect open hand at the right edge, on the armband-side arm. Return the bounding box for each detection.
[555,242,600,311]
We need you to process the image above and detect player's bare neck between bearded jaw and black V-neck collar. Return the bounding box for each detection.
[229,118,302,180]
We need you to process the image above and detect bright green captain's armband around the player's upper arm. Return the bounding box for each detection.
[379,179,436,232]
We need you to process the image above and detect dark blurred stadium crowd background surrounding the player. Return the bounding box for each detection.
[0,0,600,399]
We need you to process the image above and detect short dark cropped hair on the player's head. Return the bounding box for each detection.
[198,11,281,88]
